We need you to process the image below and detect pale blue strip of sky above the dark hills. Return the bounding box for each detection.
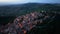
[0,0,60,5]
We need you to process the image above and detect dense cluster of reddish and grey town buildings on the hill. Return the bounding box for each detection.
[0,12,54,34]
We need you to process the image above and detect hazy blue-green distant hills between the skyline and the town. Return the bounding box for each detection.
[0,3,60,16]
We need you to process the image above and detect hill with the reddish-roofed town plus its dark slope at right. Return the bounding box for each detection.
[0,12,60,34]
